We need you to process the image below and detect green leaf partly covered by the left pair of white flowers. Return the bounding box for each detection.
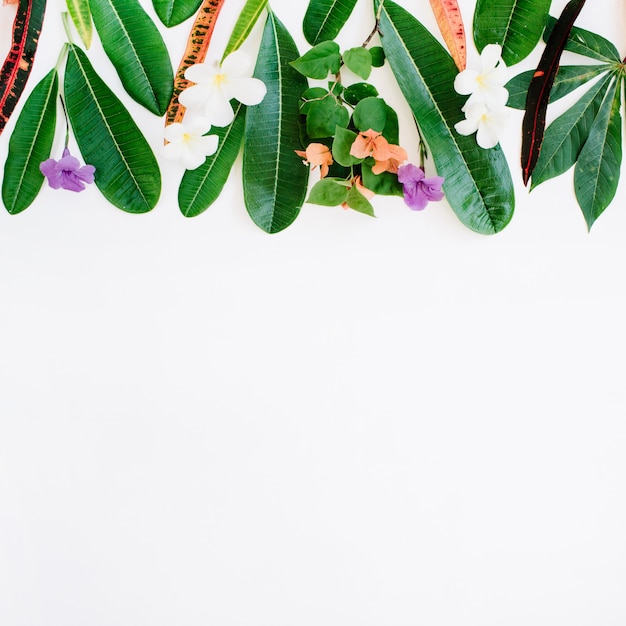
[178,104,246,217]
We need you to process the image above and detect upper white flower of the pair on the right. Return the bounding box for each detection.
[454,43,509,109]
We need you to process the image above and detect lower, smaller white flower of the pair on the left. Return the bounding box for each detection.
[163,118,218,170]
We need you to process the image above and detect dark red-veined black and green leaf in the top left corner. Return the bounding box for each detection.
[0,0,46,133]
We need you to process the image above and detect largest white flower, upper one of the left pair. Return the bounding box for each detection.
[178,50,267,126]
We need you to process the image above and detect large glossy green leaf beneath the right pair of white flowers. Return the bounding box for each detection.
[380,0,515,234]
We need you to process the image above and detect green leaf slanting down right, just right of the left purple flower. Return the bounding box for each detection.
[64,45,161,213]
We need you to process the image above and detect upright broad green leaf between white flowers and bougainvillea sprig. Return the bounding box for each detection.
[243,11,309,233]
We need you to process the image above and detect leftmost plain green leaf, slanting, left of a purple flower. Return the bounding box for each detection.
[2,69,59,214]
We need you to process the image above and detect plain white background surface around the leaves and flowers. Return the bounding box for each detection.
[0,0,626,626]
